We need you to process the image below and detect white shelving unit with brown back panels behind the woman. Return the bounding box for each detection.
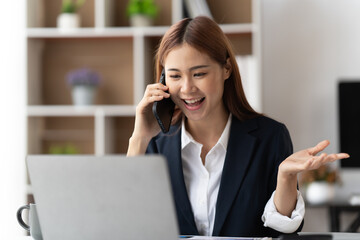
[26,0,260,199]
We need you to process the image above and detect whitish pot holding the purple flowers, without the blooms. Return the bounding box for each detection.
[72,85,96,106]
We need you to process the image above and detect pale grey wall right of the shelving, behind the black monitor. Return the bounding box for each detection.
[261,0,360,231]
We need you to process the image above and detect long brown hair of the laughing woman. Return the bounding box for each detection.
[155,16,261,121]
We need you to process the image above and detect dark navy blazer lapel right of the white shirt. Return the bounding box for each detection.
[213,117,257,236]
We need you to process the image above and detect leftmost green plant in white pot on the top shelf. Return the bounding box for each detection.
[57,0,85,30]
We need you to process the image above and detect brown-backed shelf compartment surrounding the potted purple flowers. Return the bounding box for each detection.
[28,38,135,105]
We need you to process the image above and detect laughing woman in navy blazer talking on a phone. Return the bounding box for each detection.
[128,17,348,237]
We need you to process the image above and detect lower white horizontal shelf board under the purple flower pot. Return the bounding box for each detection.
[27,105,136,117]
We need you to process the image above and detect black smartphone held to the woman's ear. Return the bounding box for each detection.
[152,69,175,133]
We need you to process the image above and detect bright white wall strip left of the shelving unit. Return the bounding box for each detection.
[0,1,26,239]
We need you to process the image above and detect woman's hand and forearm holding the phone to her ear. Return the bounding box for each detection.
[128,83,170,155]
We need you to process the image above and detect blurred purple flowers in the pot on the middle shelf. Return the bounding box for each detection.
[66,68,101,86]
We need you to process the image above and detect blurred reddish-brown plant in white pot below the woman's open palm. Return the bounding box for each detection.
[300,165,340,204]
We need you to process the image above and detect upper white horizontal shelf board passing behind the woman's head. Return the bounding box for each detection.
[27,23,254,38]
